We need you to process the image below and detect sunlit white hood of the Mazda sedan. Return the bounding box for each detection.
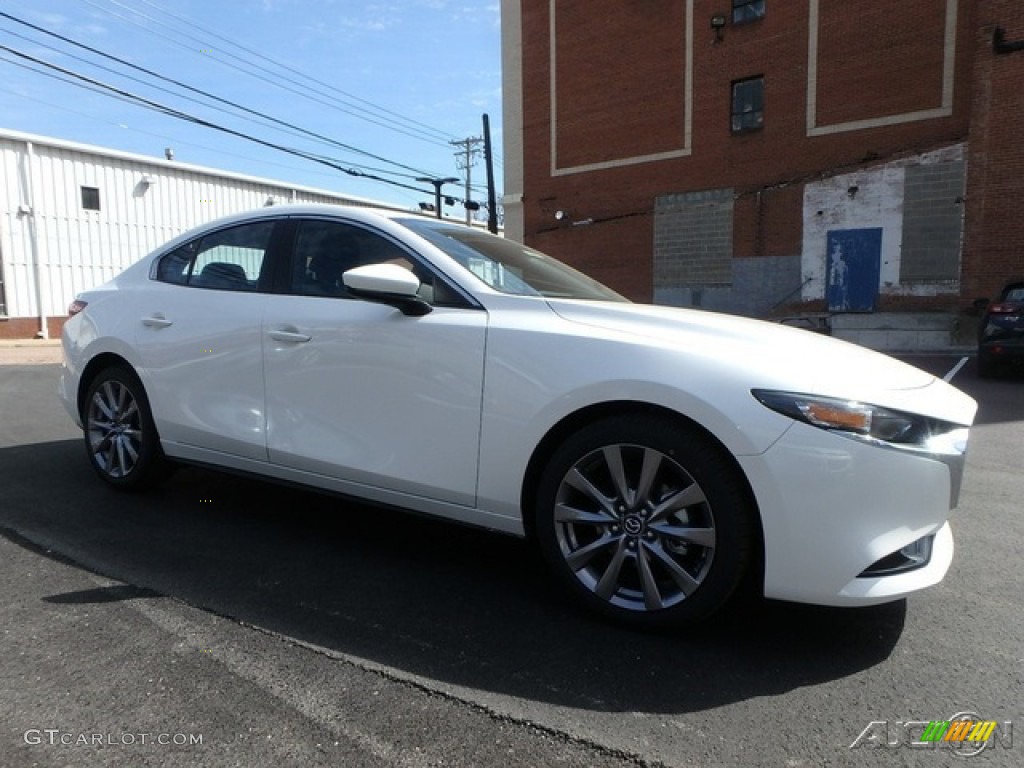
[548,300,977,424]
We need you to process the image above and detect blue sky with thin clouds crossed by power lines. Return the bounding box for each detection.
[0,0,502,216]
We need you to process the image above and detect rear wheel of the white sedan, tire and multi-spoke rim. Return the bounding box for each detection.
[82,366,168,490]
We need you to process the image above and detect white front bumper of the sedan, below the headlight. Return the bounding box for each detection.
[738,423,967,605]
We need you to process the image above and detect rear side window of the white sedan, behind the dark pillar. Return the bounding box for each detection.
[157,221,274,291]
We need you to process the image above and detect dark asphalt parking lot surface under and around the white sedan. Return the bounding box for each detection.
[0,355,1024,768]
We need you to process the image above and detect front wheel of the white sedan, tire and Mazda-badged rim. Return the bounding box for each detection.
[535,415,759,628]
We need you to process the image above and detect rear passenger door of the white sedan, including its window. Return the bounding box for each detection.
[136,219,276,461]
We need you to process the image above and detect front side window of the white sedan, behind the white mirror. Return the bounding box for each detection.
[290,220,415,298]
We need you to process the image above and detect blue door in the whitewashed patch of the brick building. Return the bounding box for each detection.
[825,227,882,312]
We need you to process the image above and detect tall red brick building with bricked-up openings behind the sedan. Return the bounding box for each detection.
[503,0,1024,323]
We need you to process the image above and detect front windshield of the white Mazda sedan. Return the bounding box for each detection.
[398,219,628,301]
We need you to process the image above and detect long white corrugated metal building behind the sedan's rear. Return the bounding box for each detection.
[0,130,403,338]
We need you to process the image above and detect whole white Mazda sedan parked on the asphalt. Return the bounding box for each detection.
[60,206,976,626]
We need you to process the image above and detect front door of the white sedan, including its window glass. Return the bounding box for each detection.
[263,219,487,506]
